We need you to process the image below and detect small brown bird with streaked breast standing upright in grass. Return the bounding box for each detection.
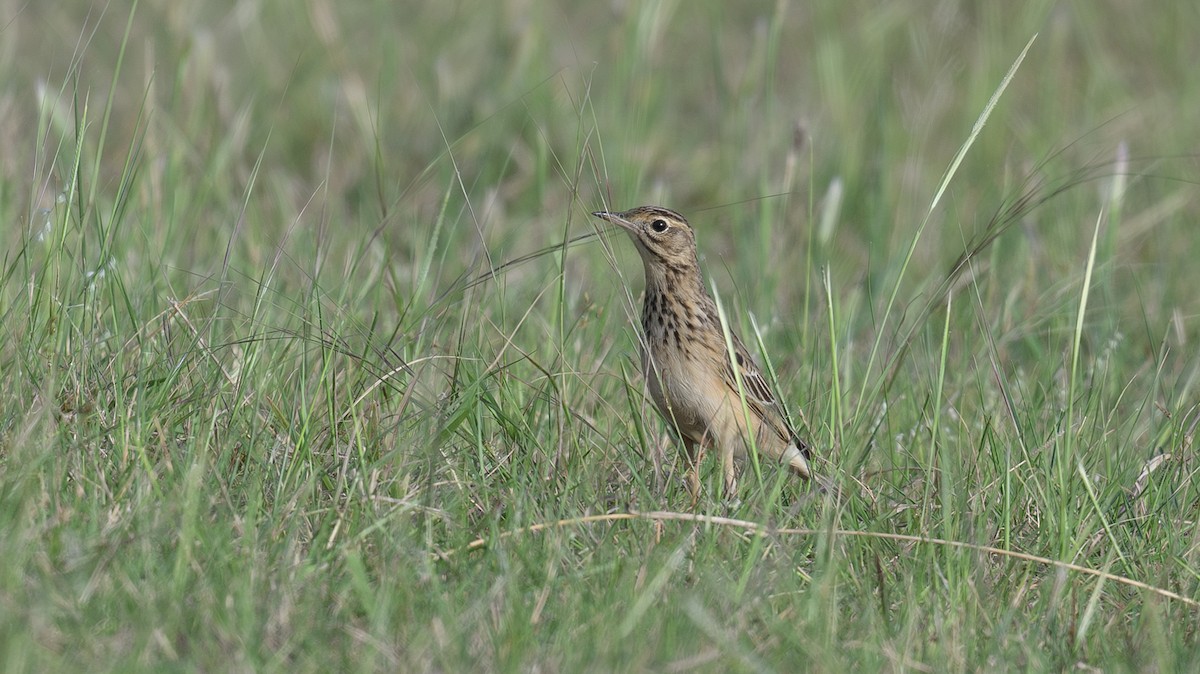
[592,206,812,503]
